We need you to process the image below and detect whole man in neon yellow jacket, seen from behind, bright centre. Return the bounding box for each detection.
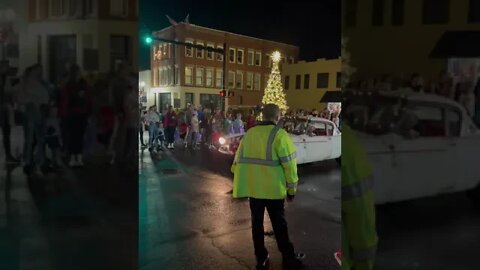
[231,104,305,269]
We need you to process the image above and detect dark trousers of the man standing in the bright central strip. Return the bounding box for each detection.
[250,198,295,261]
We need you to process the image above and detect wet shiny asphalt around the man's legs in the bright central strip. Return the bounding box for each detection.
[139,148,341,270]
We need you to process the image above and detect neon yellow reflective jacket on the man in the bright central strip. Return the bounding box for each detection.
[232,122,298,199]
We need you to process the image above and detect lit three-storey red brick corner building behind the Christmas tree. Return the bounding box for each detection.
[151,22,299,111]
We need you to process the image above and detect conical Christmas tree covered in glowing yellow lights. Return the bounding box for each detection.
[262,51,288,115]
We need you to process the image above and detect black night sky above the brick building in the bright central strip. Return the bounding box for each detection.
[139,0,341,70]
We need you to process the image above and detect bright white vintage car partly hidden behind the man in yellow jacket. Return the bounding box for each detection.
[218,118,342,164]
